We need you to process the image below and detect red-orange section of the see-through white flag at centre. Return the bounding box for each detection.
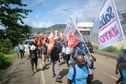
[67,32,80,48]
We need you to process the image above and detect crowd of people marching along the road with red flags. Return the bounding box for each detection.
[15,31,96,84]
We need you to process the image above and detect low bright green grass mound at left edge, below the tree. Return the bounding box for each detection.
[0,53,13,69]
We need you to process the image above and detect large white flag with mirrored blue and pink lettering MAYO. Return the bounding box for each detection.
[97,0,124,49]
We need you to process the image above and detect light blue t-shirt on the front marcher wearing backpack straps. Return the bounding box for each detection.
[68,64,89,84]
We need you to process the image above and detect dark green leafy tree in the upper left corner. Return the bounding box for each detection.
[0,0,32,45]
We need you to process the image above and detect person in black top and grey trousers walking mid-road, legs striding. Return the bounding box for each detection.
[50,42,62,83]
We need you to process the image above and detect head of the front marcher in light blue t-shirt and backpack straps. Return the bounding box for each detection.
[76,53,86,67]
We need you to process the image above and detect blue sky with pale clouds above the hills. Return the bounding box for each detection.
[0,0,126,28]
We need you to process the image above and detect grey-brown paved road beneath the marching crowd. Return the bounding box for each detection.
[0,54,117,84]
